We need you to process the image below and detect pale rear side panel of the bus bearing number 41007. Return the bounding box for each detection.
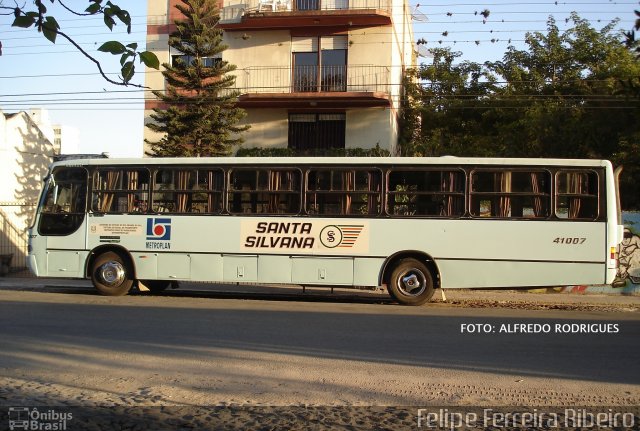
[371,219,608,288]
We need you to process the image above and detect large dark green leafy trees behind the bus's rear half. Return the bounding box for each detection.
[403,14,640,209]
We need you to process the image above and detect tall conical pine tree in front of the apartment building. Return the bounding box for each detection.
[145,0,249,157]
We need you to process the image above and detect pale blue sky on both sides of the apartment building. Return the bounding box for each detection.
[0,0,640,157]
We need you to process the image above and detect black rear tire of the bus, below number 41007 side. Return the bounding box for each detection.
[387,259,435,305]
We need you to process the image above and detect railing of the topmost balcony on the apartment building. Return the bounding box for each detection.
[220,0,391,24]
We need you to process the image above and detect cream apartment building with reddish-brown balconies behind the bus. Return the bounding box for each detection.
[145,0,415,154]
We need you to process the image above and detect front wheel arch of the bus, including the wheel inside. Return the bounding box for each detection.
[87,246,135,296]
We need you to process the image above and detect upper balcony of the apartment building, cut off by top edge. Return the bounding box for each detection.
[219,0,391,30]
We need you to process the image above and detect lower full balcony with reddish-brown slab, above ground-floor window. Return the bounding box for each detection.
[228,65,391,109]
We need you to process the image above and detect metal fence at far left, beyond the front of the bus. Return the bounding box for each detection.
[0,202,35,276]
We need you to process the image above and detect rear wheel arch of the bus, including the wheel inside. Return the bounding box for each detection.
[380,251,440,305]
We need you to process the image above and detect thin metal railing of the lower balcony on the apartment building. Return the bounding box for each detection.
[234,65,391,94]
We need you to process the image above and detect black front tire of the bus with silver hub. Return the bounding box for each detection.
[91,251,133,296]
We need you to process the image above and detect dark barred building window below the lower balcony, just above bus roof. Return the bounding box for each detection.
[289,114,346,151]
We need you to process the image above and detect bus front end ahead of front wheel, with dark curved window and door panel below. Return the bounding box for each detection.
[32,167,87,277]
